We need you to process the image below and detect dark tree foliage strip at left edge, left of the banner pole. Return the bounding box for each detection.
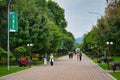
[0,0,7,50]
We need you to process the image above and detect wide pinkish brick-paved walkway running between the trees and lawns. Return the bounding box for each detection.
[0,55,115,80]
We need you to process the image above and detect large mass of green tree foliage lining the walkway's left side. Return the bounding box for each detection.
[0,0,74,60]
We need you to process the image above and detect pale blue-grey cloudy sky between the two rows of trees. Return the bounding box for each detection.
[54,0,107,38]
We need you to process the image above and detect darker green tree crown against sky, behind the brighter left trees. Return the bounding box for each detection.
[48,0,67,28]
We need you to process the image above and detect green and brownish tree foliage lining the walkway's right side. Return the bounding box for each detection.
[83,1,120,56]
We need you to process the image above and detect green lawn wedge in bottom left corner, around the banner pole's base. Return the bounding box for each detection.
[0,66,28,77]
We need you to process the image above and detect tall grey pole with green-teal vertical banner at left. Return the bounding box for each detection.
[7,10,18,70]
